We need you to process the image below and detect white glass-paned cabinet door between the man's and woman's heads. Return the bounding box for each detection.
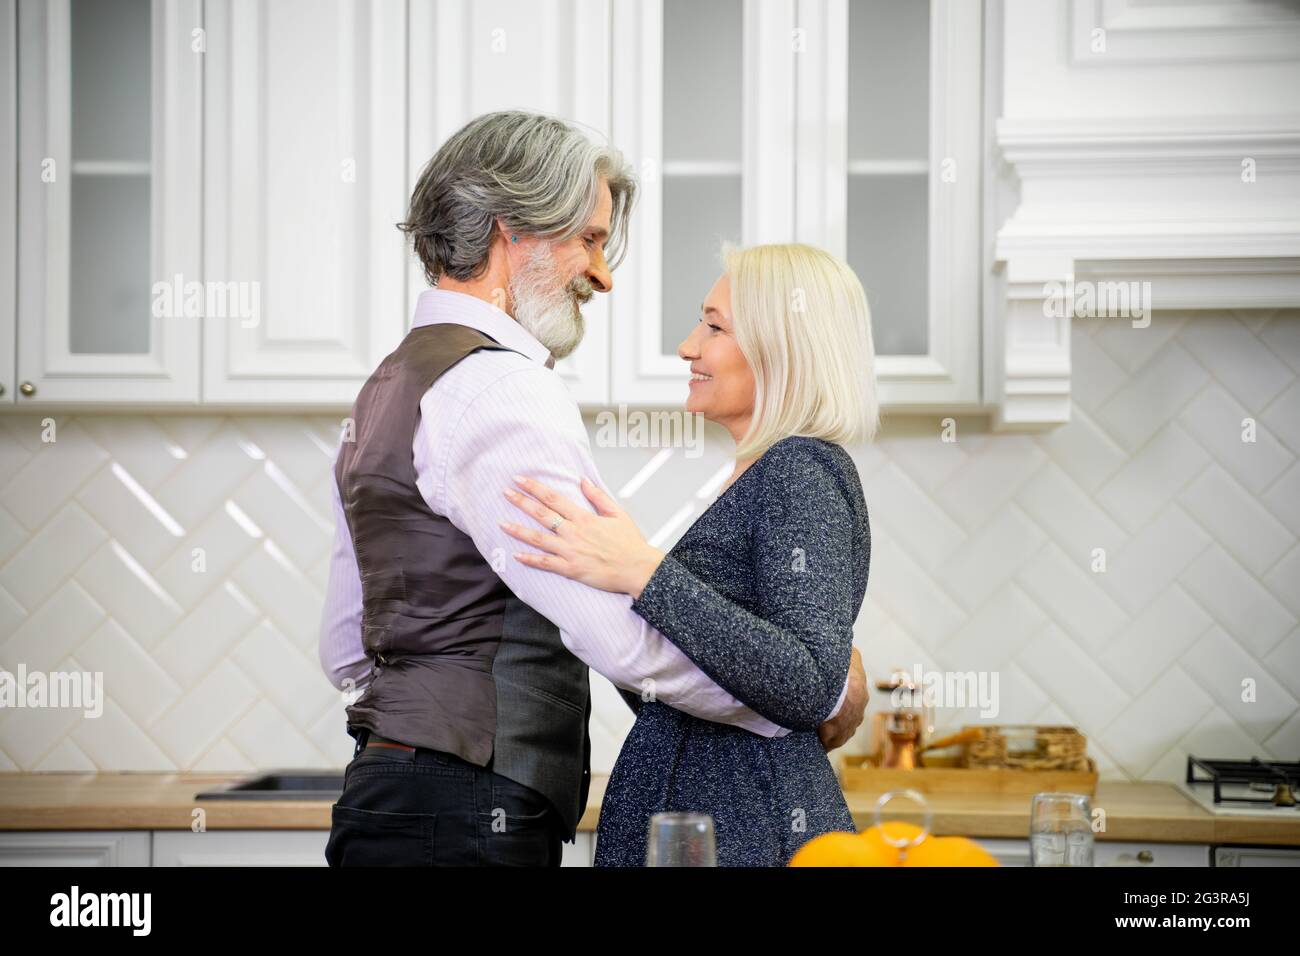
[611,0,794,406]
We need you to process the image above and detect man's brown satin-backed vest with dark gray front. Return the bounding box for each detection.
[334,323,592,839]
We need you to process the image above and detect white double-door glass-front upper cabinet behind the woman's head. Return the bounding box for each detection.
[610,0,983,408]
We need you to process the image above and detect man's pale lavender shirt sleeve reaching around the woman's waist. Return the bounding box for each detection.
[417,365,789,737]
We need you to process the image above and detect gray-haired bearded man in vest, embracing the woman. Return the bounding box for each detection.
[320,112,865,866]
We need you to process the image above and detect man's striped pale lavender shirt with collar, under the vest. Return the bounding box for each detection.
[320,289,848,736]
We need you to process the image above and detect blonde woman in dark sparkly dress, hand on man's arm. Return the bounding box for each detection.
[507,245,878,866]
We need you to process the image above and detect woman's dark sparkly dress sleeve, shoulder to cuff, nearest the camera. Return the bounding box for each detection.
[632,445,857,730]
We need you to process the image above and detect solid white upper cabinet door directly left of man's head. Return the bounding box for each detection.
[203,0,408,405]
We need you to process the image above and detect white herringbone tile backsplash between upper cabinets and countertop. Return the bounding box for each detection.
[0,311,1300,779]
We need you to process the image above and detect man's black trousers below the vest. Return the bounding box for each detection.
[325,727,563,866]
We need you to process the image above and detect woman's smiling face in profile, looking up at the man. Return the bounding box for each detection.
[677,274,754,441]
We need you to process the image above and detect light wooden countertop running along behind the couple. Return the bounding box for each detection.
[0,773,1300,847]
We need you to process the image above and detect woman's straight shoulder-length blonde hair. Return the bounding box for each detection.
[723,243,880,459]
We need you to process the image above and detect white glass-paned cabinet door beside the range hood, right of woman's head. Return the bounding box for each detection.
[796,0,983,408]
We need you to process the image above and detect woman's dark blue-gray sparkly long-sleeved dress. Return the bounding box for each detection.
[595,437,871,866]
